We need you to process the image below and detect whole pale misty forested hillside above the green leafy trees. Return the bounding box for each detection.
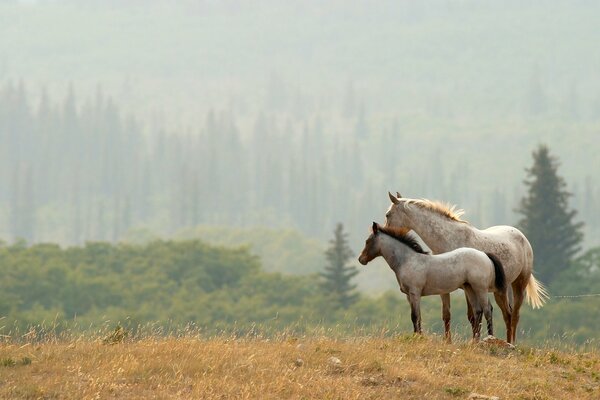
[0,0,600,253]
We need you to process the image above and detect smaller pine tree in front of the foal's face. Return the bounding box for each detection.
[320,223,358,308]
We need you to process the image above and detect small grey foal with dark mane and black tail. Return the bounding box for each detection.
[358,222,507,340]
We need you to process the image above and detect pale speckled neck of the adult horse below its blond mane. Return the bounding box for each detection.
[411,209,476,254]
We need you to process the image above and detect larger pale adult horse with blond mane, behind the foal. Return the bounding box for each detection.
[385,193,548,343]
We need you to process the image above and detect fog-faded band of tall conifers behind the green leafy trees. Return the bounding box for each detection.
[0,81,600,244]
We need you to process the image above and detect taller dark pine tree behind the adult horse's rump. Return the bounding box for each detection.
[517,145,583,283]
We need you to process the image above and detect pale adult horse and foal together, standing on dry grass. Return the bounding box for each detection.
[359,193,548,343]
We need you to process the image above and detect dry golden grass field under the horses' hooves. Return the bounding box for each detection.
[0,336,600,400]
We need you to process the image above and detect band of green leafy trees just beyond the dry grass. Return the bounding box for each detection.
[0,240,600,346]
